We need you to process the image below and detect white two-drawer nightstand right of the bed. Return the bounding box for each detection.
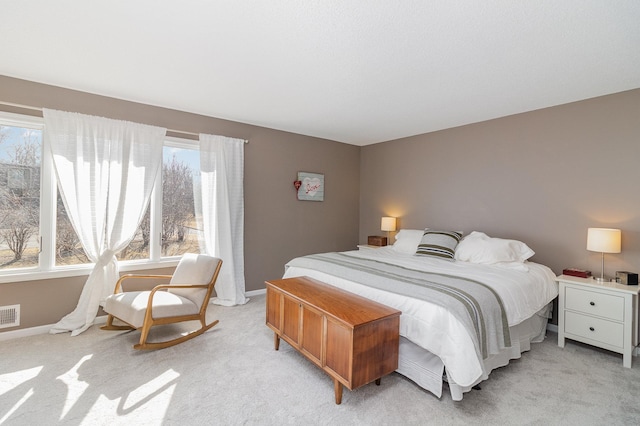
[556,275,639,368]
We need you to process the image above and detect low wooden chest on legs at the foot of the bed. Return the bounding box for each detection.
[265,277,401,404]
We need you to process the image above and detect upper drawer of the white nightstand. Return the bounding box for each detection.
[565,287,624,321]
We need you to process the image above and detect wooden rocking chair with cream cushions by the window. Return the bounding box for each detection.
[100,253,222,349]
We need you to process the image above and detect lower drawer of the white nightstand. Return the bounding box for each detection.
[564,311,624,348]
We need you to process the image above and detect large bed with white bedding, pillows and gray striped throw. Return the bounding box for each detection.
[284,229,558,401]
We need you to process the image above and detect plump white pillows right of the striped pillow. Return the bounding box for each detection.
[454,231,535,265]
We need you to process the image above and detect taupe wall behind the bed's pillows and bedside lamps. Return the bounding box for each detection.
[360,89,640,274]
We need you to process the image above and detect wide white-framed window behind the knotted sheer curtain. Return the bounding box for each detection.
[0,112,202,279]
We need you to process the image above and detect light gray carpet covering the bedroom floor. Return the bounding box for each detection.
[0,295,640,426]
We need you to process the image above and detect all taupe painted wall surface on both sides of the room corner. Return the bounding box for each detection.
[0,76,640,331]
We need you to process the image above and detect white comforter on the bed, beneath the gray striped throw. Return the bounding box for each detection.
[284,247,558,386]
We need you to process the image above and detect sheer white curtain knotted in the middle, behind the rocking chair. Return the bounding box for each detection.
[44,109,166,336]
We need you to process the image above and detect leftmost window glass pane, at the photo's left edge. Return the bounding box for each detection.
[0,124,42,269]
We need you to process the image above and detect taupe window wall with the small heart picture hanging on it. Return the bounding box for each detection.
[0,76,360,332]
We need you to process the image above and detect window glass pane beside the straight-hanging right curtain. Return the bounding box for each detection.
[161,147,201,256]
